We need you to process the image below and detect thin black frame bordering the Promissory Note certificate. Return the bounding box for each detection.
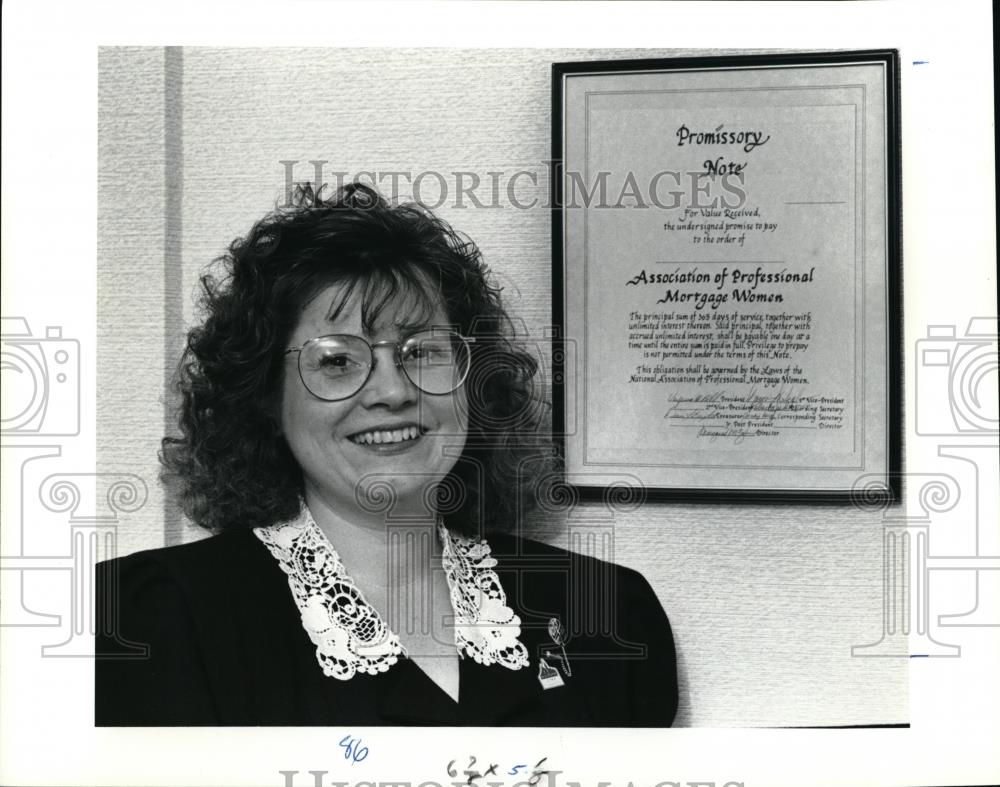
[550,49,903,504]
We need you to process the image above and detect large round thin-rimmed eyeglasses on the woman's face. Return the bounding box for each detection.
[285,328,475,402]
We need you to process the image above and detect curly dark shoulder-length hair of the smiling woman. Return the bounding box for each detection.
[160,183,552,534]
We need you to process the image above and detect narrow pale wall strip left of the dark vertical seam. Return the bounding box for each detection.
[97,48,171,554]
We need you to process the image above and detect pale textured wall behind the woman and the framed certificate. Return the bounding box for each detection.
[98,49,907,726]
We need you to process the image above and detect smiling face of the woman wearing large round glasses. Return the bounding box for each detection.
[279,285,468,530]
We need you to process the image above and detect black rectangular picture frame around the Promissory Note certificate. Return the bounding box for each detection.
[550,49,903,506]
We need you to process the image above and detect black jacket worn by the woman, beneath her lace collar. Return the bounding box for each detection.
[95,530,677,727]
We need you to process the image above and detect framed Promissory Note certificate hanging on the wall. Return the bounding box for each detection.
[552,51,901,502]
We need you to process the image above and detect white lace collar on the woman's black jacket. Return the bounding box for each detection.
[253,505,528,680]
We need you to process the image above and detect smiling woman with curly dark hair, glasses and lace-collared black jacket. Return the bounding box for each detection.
[96,184,677,726]
